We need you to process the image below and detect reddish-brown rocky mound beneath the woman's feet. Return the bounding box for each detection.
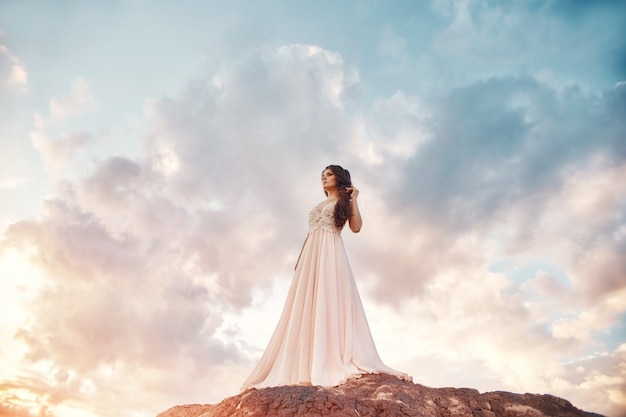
[157,375,601,417]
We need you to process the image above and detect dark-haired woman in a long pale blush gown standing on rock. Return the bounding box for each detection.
[242,165,409,389]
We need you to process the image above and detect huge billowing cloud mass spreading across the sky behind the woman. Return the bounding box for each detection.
[1,35,626,413]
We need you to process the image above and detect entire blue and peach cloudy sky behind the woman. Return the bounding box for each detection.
[0,0,626,417]
